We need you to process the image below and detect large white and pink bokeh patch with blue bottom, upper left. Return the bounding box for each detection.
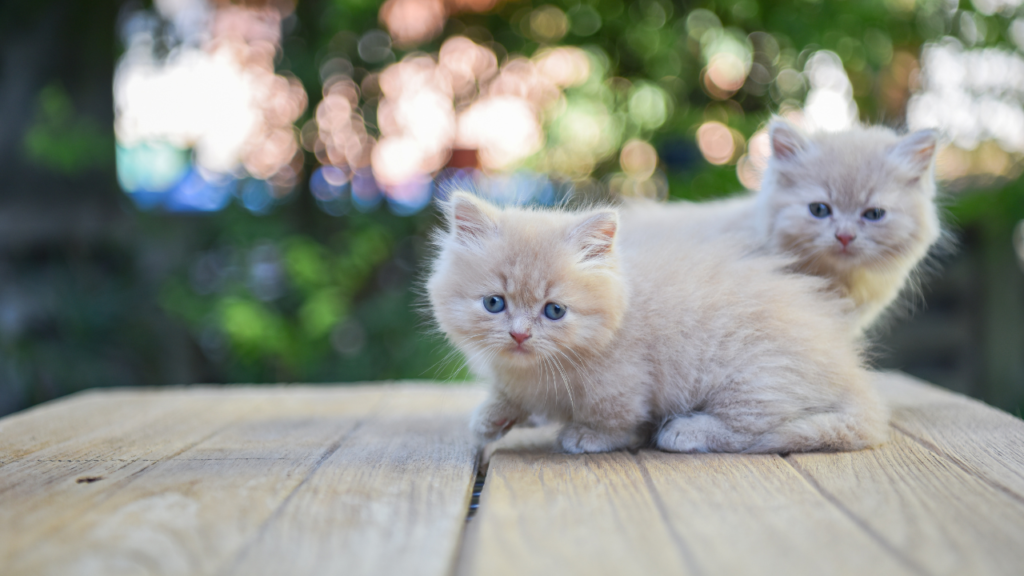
[114,0,307,211]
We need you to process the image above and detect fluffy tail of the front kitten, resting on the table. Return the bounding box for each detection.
[745,389,889,453]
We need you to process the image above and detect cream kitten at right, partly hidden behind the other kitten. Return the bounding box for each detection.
[624,120,941,330]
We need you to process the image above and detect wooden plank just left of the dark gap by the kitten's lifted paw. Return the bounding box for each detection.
[223,386,483,576]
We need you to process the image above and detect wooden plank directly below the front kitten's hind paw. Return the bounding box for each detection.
[637,451,914,576]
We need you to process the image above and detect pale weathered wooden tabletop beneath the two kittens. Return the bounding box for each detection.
[0,374,1024,576]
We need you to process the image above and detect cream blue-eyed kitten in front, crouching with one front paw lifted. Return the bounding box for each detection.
[427,194,887,453]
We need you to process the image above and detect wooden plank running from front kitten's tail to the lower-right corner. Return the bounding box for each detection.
[786,429,1024,575]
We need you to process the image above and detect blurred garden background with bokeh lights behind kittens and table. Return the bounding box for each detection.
[0,0,1024,415]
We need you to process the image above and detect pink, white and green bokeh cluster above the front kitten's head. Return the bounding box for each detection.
[301,36,630,208]
